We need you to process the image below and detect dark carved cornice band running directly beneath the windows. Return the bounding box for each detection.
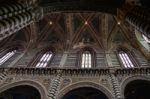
[0,67,150,76]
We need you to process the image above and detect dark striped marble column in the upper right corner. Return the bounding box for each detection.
[125,6,150,39]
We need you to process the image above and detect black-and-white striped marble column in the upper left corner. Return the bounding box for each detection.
[0,3,34,40]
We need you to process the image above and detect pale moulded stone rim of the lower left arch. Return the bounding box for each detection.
[0,80,46,99]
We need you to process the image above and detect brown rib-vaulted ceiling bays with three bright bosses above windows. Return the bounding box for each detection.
[33,12,136,50]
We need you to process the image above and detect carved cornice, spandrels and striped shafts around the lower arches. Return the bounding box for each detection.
[0,67,150,99]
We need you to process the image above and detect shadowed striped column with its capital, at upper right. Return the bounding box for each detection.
[117,5,150,39]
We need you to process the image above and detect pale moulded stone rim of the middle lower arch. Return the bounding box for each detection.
[57,82,113,99]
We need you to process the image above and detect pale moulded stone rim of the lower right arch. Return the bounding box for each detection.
[120,75,150,96]
